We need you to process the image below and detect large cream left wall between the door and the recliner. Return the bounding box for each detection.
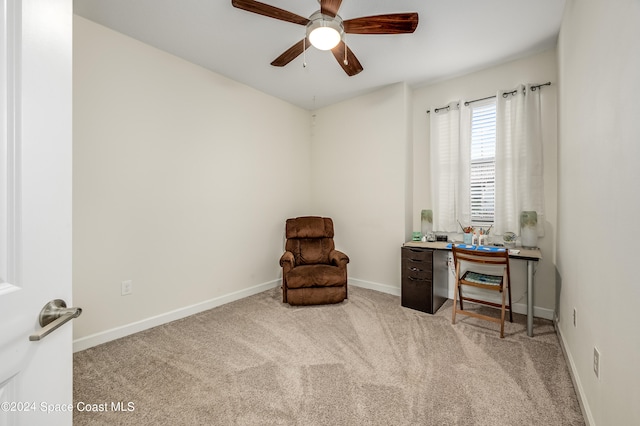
[73,16,311,349]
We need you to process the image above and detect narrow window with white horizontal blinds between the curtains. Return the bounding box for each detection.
[470,99,496,224]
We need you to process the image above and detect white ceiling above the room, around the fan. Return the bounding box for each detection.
[74,0,565,110]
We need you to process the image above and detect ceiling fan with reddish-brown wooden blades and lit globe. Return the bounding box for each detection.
[231,0,418,76]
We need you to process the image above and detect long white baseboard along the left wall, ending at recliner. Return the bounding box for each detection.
[73,279,282,352]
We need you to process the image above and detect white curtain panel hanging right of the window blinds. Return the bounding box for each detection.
[494,85,544,237]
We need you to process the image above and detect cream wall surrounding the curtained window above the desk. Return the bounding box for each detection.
[412,49,558,319]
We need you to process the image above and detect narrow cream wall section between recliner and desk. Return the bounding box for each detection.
[311,83,410,294]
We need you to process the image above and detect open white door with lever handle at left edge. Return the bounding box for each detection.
[0,0,73,426]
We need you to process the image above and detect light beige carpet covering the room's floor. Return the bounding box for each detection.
[74,286,584,426]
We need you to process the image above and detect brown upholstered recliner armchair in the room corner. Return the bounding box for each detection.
[280,216,349,305]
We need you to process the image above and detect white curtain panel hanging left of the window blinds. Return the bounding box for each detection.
[429,102,471,232]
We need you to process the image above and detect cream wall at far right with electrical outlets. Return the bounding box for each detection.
[557,0,640,426]
